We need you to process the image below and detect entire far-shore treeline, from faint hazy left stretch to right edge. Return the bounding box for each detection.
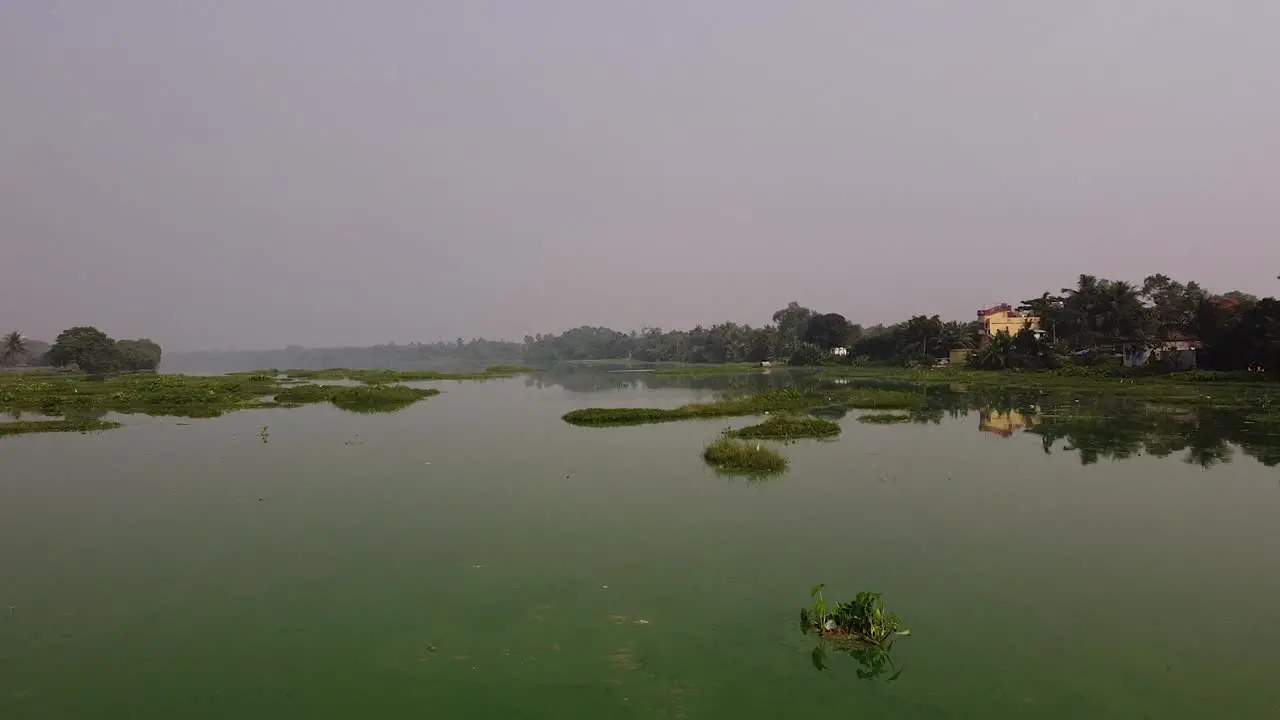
[57,267,1280,375]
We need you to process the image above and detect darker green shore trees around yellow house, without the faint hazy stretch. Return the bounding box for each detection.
[514,274,1280,372]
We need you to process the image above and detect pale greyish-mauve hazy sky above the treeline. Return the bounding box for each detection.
[0,0,1280,350]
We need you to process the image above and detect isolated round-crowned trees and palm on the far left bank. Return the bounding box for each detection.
[0,325,161,375]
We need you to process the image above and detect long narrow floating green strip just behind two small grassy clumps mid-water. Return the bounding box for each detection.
[563,387,924,427]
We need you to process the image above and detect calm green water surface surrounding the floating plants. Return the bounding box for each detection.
[0,375,1280,720]
